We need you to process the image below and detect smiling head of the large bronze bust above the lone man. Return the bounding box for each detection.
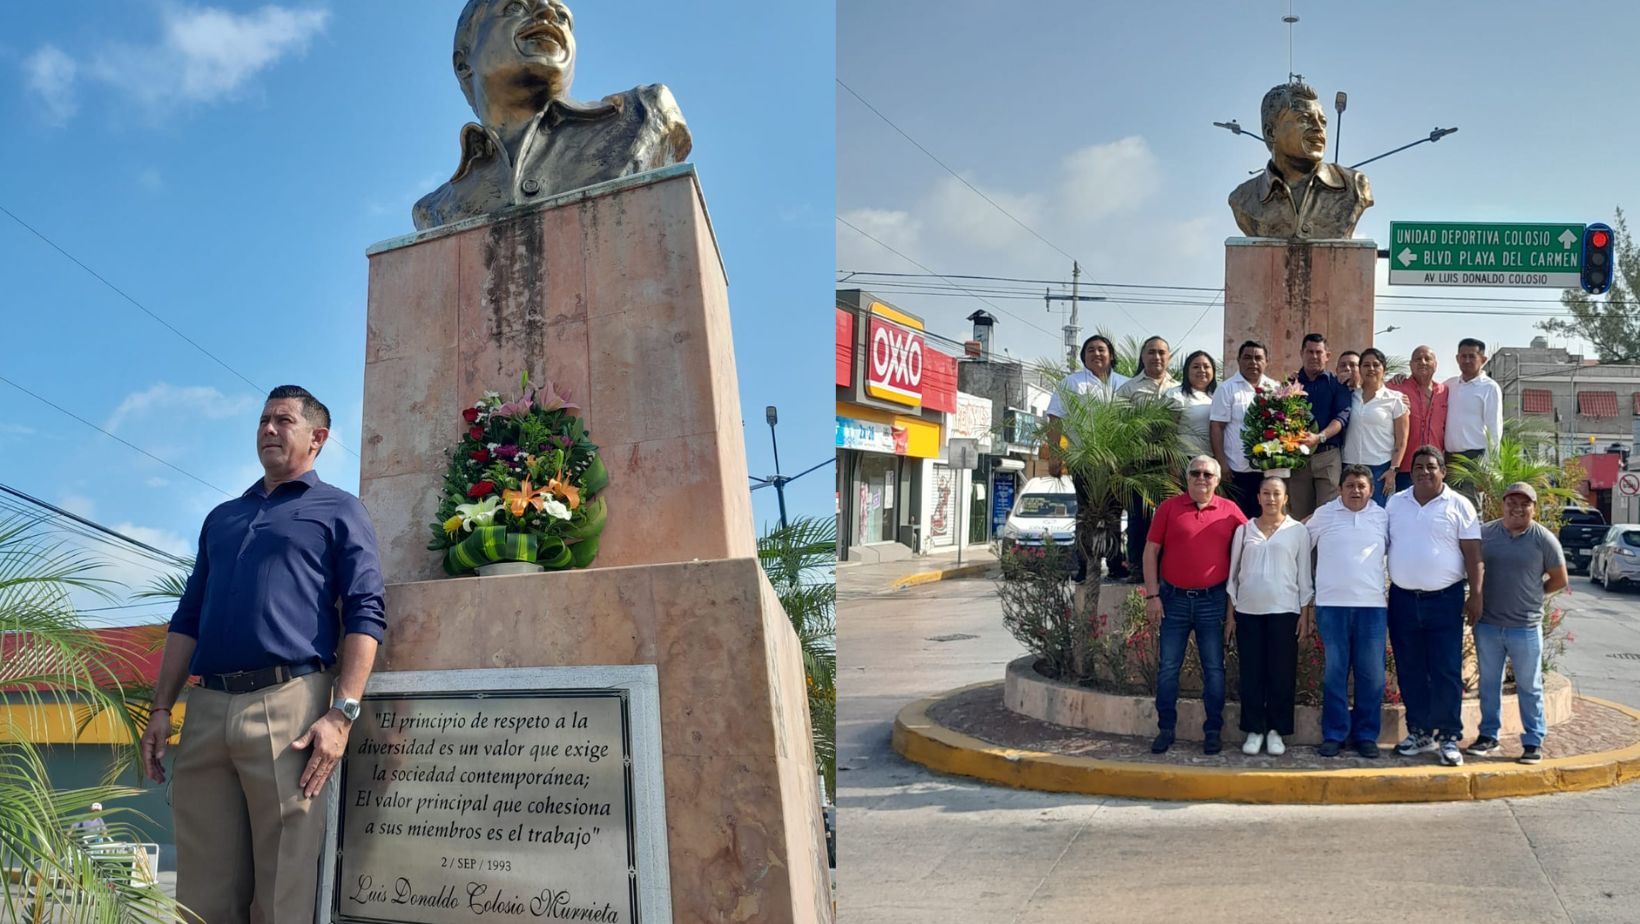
[454,0,576,126]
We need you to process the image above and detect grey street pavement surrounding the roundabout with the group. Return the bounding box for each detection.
[836,563,1640,924]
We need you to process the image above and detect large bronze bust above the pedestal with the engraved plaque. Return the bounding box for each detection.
[412,0,690,230]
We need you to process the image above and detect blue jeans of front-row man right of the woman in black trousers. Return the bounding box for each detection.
[1315,606,1389,742]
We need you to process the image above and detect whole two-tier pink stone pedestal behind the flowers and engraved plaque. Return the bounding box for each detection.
[359,164,831,922]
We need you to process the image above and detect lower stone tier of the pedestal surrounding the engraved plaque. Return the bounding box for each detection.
[377,558,831,924]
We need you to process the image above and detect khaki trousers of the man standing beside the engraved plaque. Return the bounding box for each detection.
[171,671,335,924]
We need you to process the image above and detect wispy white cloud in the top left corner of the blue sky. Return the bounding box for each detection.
[25,3,330,123]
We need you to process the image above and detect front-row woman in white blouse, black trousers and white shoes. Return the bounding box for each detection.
[1225,478,1315,757]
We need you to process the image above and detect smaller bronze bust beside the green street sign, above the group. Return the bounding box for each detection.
[1230,82,1373,240]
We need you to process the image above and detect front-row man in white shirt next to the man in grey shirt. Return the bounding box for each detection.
[1384,446,1483,766]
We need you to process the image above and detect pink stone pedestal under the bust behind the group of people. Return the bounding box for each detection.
[1220,238,1378,379]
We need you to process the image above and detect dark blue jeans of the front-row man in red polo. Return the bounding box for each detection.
[1156,581,1228,735]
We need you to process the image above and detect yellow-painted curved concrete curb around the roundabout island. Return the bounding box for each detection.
[894,681,1640,804]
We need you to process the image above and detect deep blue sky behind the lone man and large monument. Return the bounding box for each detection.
[0,0,835,617]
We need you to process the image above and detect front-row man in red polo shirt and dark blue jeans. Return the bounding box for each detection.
[1145,456,1246,753]
